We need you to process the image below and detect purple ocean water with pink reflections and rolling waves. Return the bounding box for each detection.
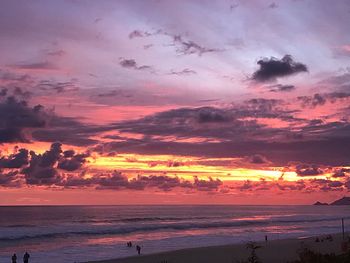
[0,206,350,263]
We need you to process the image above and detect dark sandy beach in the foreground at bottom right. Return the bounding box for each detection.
[87,234,348,263]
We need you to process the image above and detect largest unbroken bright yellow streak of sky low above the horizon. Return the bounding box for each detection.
[89,154,300,181]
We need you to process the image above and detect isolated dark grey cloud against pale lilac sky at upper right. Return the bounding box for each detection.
[252,55,308,82]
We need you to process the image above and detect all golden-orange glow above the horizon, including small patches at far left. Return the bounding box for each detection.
[2,142,342,186]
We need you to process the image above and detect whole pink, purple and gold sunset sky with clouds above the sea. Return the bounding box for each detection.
[0,0,350,205]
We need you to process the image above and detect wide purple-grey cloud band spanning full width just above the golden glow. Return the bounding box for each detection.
[0,84,350,170]
